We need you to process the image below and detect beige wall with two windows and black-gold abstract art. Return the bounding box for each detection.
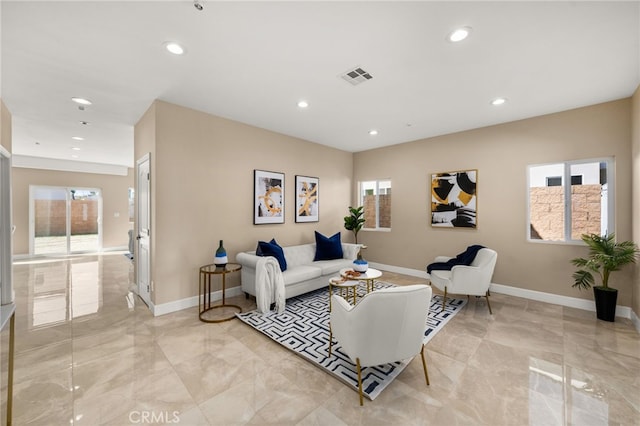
[353,99,632,306]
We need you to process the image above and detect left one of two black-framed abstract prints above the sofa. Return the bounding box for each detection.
[253,170,284,225]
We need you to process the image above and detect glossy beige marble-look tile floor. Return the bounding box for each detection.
[6,253,640,426]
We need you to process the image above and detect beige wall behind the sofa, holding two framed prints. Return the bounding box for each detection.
[135,101,353,304]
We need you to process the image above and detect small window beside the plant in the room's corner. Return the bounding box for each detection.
[359,179,391,229]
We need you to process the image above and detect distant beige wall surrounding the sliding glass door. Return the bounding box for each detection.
[12,167,133,254]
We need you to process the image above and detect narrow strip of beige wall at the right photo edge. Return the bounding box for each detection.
[631,86,640,317]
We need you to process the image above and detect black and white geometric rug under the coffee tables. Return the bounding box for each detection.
[236,282,467,400]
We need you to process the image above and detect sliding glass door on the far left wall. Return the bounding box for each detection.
[29,186,102,255]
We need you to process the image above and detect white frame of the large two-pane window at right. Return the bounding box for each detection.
[525,157,616,245]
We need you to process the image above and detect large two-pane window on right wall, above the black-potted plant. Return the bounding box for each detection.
[528,158,614,242]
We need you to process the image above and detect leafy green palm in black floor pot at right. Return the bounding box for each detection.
[571,234,640,322]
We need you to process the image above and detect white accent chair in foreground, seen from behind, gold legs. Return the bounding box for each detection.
[329,284,432,405]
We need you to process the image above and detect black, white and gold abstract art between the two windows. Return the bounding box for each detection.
[431,170,478,228]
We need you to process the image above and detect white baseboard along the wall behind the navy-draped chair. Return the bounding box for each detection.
[370,262,640,322]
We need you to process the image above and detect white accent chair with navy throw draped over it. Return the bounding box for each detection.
[429,247,498,315]
